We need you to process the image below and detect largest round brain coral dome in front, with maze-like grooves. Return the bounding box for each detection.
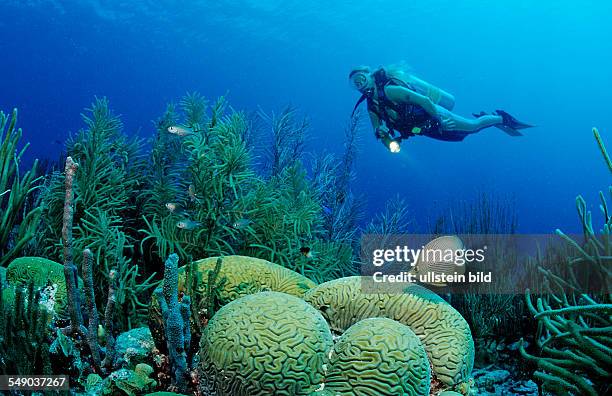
[199,292,333,396]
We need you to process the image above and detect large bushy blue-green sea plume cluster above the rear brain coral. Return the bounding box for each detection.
[141,94,356,281]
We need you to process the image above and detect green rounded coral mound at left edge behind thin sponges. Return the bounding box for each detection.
[6,257,83,319]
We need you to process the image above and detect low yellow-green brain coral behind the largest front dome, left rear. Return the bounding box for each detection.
[149,256,316,350]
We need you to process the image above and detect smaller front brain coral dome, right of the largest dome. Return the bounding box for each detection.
[325,318,430,396]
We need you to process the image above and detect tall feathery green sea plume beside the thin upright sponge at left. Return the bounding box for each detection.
[38,98,155,328]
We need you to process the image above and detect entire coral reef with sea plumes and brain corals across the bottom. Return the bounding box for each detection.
[0,93,612,396]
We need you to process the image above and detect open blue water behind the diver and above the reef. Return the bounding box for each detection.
[0,0,612,232]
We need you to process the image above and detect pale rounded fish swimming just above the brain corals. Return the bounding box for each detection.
[410,235,465,287]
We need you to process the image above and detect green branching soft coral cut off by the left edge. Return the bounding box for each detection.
[0,109,42,267]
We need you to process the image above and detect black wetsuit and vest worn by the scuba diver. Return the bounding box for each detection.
[366,69,470,142]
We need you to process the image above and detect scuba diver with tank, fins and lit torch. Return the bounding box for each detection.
[349,66,533,153]
